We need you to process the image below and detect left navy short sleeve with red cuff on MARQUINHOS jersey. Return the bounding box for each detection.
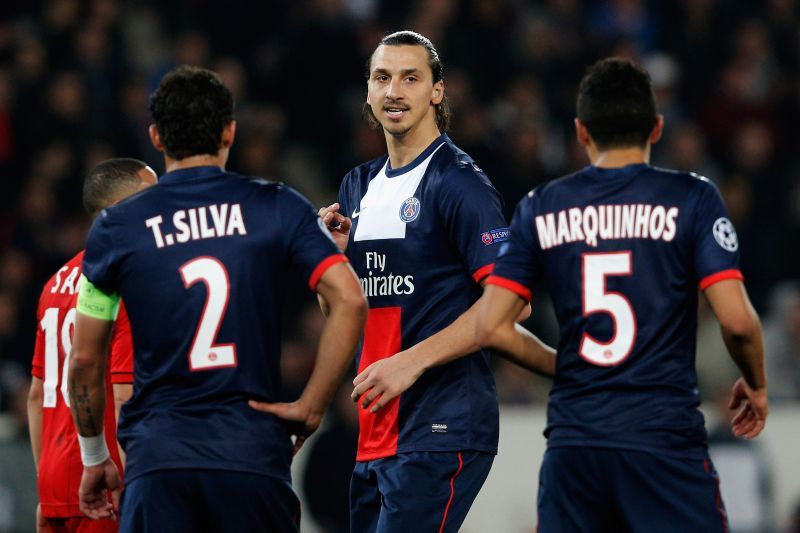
[486,194,542,301]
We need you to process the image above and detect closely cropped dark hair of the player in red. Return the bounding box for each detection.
[83,157,147,217]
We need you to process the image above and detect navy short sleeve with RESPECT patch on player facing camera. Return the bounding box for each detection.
[437,168,509,283]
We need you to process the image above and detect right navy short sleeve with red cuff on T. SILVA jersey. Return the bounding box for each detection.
[278,186,347,290]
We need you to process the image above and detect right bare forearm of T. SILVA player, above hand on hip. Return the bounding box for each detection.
[300,301,367,416]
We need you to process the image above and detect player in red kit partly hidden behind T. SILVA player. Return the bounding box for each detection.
[28,158,156,533]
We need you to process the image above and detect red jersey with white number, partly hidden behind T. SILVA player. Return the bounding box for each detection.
[31,252,133,518]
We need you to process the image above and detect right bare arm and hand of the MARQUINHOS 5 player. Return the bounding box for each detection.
[705,279,769,439]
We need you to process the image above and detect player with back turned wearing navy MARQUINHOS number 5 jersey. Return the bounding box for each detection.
[477,59,768,533]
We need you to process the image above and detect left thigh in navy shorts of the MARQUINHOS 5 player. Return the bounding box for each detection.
[537,447,618,533]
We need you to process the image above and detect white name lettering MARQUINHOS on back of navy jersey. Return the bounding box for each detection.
[536,204,679,250]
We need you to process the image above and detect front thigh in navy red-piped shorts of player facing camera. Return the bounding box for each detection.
[374,451,494,533]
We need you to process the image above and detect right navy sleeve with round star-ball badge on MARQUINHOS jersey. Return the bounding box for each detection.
[692,179,743,290]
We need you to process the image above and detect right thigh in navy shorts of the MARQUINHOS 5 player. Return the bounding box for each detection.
[614,451,728,533]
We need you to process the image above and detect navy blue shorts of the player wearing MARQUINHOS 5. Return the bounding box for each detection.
[538,447,728,533]
